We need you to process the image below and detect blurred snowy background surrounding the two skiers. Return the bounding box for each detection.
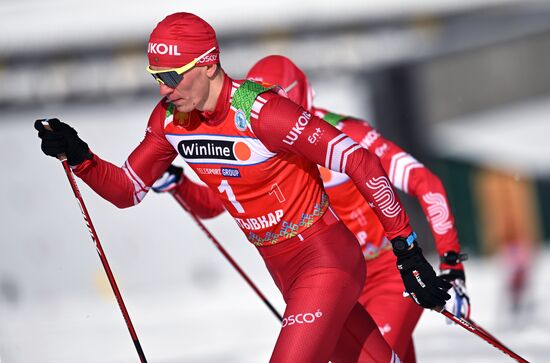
[0,0,550,363]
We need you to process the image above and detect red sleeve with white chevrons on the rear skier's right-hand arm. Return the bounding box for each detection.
[341,120,463,269]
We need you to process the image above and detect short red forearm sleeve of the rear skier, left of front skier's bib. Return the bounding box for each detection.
[172,174,225,219]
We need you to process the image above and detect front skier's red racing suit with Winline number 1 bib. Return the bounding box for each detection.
[70,75,412,362]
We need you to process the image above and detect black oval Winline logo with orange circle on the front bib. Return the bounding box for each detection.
[178,140,252,161]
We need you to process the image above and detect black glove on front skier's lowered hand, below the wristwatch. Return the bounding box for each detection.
[392,237,451,309]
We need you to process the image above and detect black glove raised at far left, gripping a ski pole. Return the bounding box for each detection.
[34,118,92,166]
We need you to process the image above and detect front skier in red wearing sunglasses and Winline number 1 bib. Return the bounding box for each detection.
[35,13,450,363]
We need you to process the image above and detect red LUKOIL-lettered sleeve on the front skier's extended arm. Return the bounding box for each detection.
[251,95,412,240]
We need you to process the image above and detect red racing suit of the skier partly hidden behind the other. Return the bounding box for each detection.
[312,108,463,363]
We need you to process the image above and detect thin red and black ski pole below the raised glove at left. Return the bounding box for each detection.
[42,119,147,363]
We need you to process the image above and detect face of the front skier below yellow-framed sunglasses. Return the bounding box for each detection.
[158,67,209,112]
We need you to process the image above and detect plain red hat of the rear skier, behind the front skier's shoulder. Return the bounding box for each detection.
[246,55,314,111]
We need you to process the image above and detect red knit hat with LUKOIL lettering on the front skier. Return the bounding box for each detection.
[151,13,220,68]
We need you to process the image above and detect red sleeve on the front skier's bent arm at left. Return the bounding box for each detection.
[73,101,177,208]
